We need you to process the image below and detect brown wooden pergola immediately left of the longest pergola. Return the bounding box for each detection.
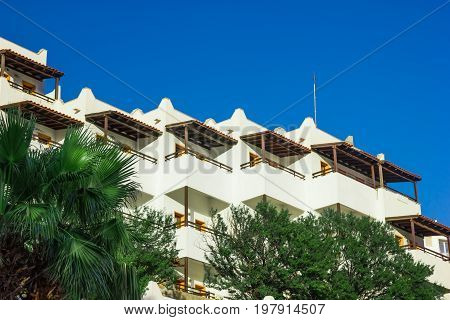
[241,130,311,159]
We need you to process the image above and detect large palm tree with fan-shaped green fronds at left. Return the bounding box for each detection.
[0,112,139,299]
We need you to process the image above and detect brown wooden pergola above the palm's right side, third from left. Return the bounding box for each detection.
[86,110,162,141]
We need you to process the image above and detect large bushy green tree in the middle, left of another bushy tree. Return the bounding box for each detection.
[206,203,332,299]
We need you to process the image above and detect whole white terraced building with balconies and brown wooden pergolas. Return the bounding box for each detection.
[0,38,450,295]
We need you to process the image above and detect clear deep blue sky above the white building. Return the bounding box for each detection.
[0,0,450,225]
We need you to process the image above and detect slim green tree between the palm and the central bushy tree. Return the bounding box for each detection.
[123,207,178,295]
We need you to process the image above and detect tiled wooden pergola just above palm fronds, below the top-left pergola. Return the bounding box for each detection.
[0,101,83,130]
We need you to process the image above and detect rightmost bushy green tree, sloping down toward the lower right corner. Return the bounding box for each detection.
[318,210,444,299]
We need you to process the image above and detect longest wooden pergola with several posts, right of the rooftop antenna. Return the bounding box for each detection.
[311,142,422,201]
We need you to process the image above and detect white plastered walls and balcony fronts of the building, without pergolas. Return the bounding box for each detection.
[0,38,450,298]
